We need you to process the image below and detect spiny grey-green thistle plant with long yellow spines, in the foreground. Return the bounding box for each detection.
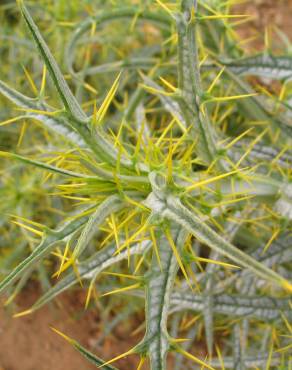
[0,0,292,370]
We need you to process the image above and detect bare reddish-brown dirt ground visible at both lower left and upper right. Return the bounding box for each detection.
[0,0,292,370]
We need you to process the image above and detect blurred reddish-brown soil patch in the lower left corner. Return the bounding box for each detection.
[0,284,139,370]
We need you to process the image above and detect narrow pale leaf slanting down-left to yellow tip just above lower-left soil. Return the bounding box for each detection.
[30,241,150,311]
